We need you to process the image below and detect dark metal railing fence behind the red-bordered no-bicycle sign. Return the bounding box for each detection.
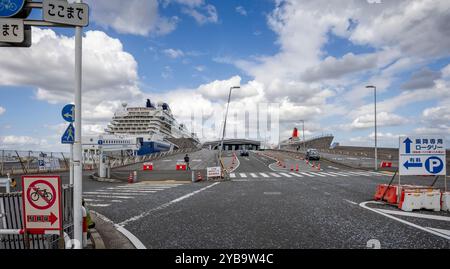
[0,185,73,249]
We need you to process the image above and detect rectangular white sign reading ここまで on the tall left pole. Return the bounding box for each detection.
[43,0,89,27]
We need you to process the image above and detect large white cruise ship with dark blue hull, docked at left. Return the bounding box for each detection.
[83,99,200,156]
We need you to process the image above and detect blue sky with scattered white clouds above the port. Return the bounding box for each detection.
[0,0,450,150]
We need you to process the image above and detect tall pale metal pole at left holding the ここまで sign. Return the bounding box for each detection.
[73,0,83,249]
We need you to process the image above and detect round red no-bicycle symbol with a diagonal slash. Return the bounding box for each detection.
[27,180,56,210]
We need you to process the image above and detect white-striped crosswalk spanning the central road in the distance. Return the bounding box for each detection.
[230,170,387,179]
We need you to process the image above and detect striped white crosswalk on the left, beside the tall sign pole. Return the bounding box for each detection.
[83,182,182,208]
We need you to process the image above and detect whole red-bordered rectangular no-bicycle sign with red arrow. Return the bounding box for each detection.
[22,176,62,234]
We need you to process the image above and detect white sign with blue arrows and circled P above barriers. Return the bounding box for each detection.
[399,136,447,176]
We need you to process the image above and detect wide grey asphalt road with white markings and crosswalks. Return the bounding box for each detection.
[84,151,450,249]
